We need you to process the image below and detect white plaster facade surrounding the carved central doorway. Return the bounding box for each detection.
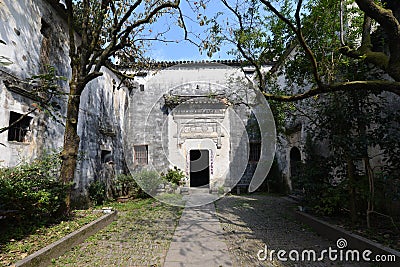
[128,63,251,191]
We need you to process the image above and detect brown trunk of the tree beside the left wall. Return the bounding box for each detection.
[60,77,82,214]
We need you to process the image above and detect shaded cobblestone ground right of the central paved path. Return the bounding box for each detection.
[216,195,368,267]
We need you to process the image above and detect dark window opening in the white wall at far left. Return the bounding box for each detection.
[8,111,32,143]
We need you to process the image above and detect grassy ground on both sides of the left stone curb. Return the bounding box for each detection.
[0,196,183,266]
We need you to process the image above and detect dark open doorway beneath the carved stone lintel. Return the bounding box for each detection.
[190,150,210,187]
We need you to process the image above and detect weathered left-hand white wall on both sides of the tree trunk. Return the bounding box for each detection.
[0,0,129,201]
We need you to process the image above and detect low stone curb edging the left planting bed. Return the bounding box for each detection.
[14,211,117,267]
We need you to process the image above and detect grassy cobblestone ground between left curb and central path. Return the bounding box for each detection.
[52,199,182,267]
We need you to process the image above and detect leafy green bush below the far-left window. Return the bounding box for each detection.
[0,153,71,219]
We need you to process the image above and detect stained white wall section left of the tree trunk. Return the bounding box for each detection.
[0,0,70,166]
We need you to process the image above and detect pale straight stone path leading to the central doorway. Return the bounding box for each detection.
[164,191,233,267]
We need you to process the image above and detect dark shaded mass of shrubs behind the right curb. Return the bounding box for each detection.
[293,91,400,221]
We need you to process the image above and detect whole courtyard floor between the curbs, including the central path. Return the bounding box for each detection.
[45,194,376,266]
